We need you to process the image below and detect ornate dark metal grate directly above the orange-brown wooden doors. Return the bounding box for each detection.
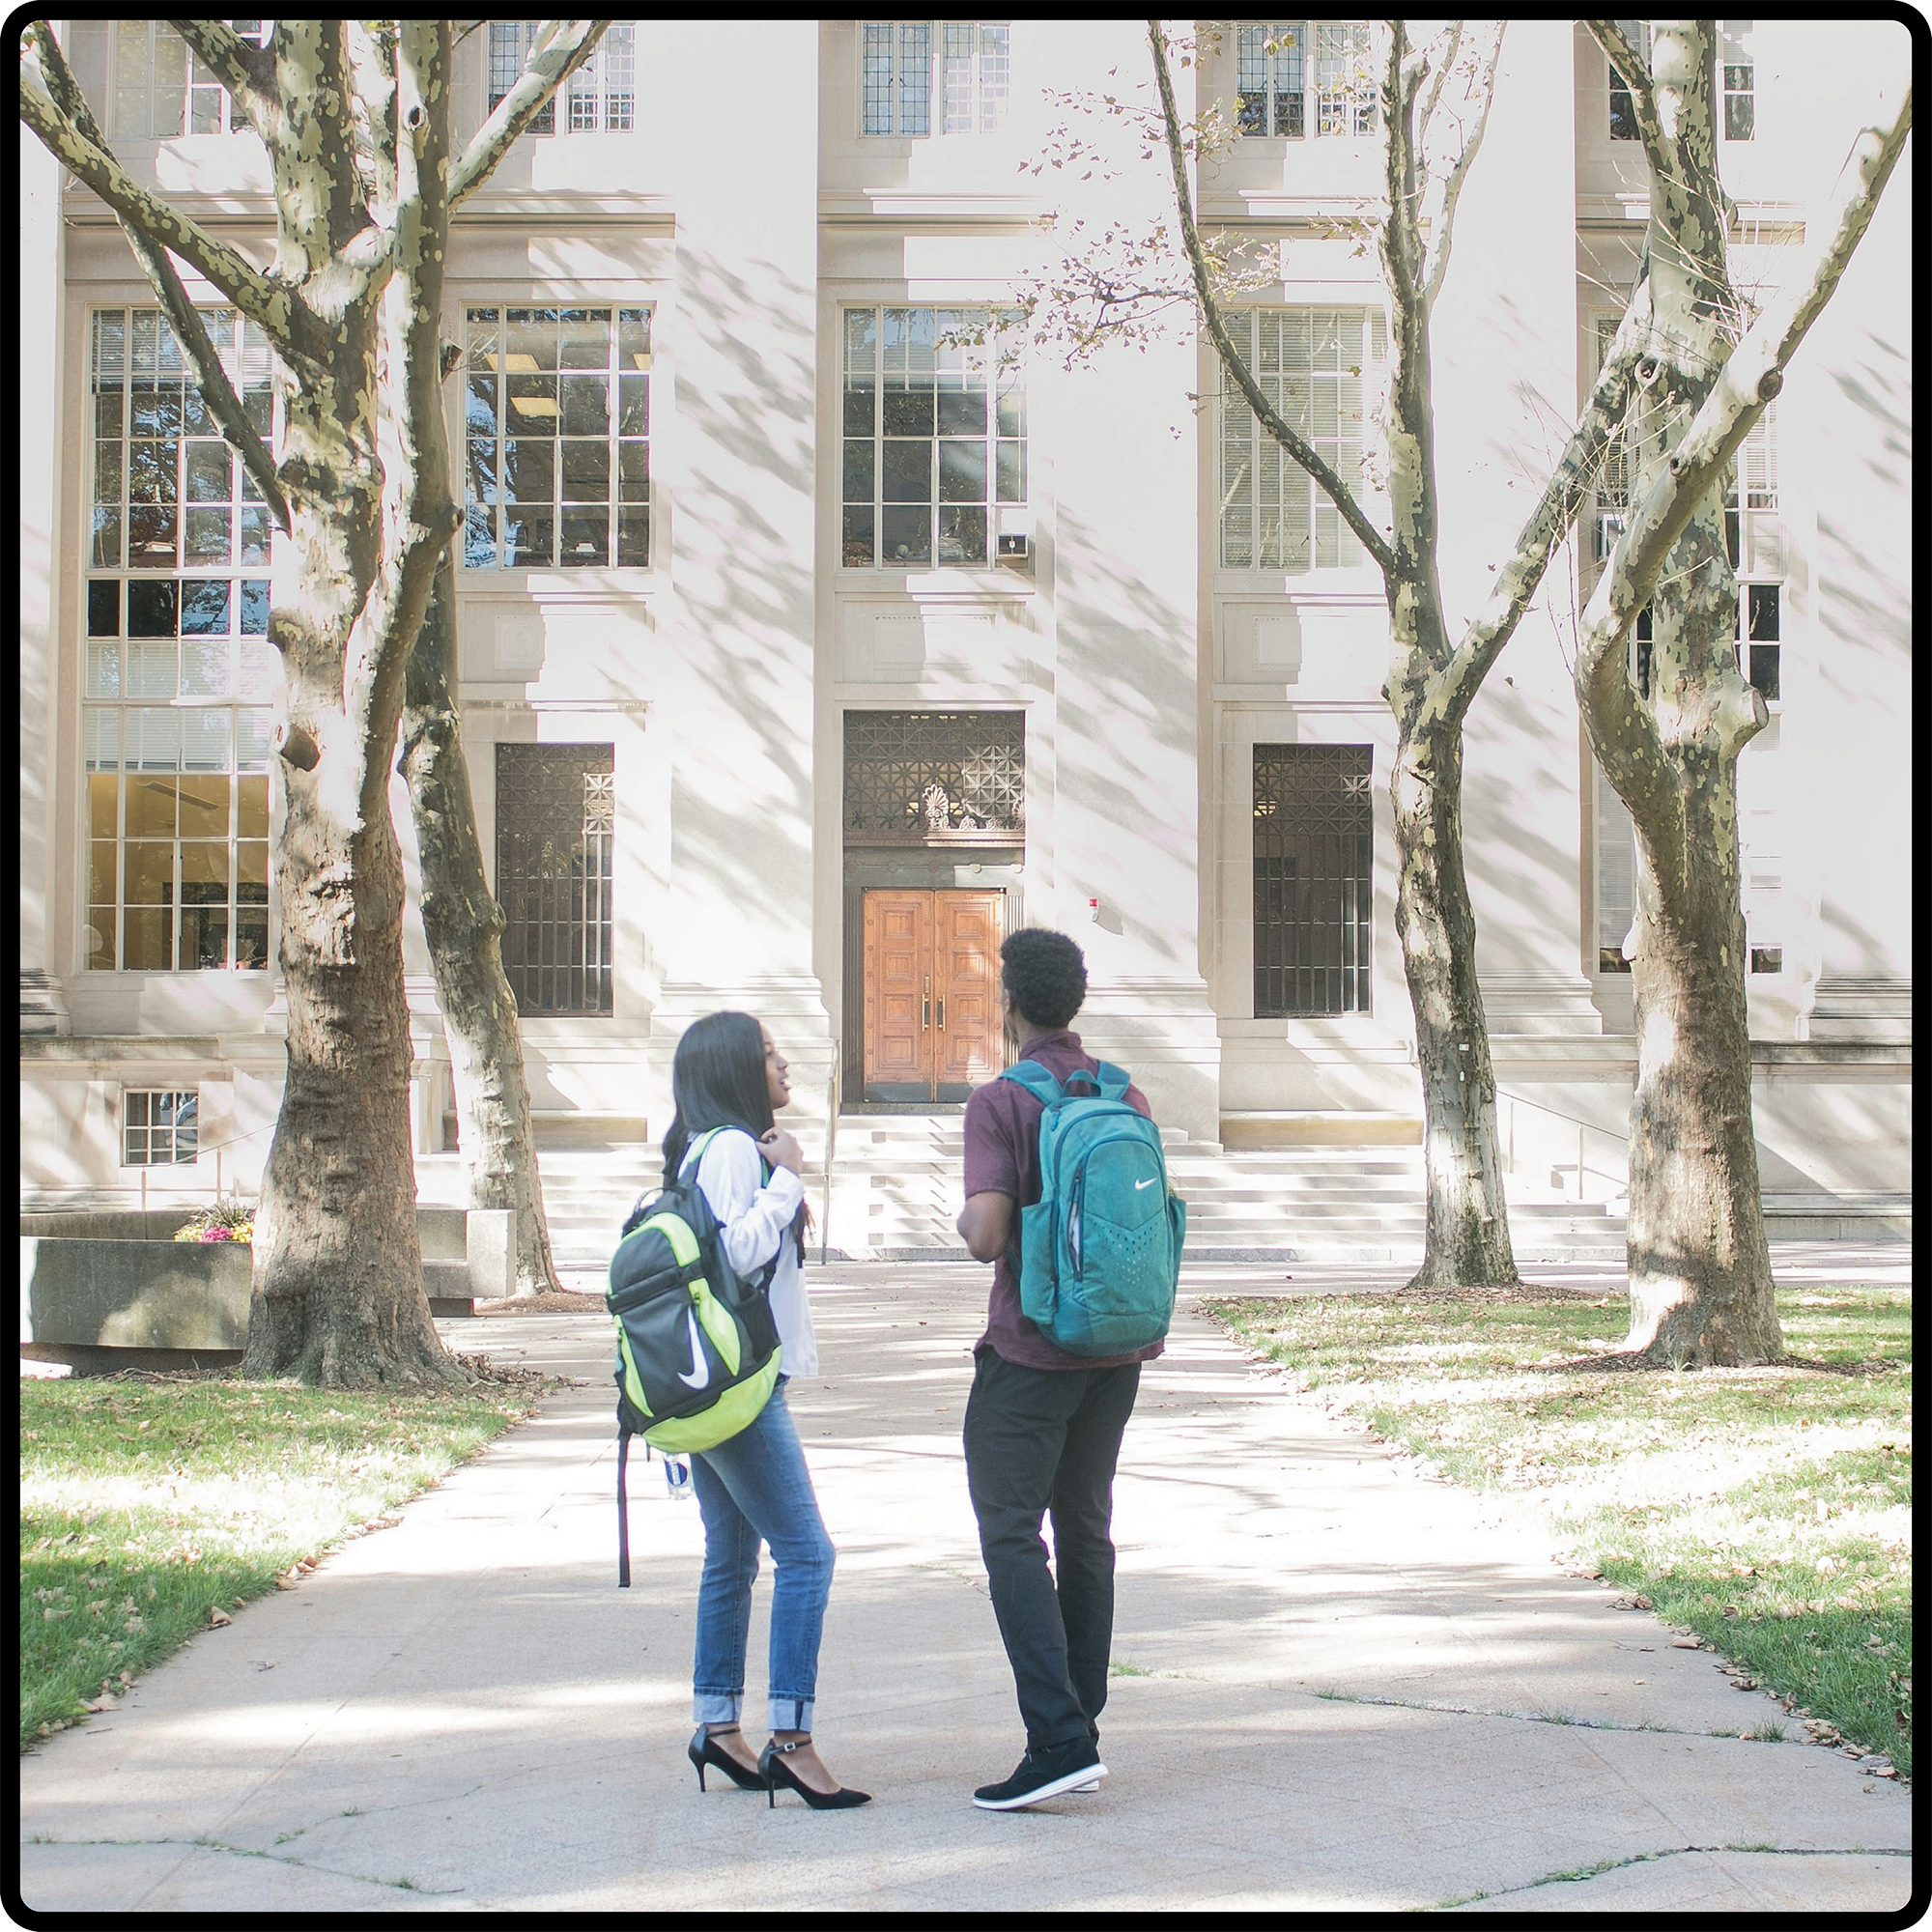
[844,711,1026,846]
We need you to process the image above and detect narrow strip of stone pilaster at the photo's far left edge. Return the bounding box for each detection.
[17,128,70,1034]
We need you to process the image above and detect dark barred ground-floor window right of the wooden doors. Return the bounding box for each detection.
[1254,744,1376,1020]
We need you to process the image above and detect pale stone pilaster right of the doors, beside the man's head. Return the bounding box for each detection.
[1028,21,1221,1142]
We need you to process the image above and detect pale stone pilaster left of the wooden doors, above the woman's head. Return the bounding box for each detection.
[647,19,831,1128]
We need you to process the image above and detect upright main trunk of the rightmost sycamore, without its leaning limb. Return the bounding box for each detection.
[1580,21,1783,1364]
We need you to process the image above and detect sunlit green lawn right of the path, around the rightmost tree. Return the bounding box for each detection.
[1202,1285,1913,1777]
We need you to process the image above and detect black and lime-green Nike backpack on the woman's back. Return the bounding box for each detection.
[605,1128,784,1588]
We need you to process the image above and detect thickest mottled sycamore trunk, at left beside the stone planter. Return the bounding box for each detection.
[242,21,456,1385]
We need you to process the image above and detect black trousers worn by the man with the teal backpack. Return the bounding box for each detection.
[966,1349,1140,1750]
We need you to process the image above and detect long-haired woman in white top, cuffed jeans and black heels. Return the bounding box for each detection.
[665,1012,869,1810]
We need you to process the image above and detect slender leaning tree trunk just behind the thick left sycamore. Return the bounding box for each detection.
[396,551,558,1294]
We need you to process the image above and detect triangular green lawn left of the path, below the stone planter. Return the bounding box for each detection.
[19,1376,539,1748]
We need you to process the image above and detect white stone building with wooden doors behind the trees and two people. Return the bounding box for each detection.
[21,19,1913,1238]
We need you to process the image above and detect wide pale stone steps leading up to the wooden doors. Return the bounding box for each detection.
[417,1113,1623,1271]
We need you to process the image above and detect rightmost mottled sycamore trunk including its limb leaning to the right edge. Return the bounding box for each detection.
[1577,21,1911,1366]
